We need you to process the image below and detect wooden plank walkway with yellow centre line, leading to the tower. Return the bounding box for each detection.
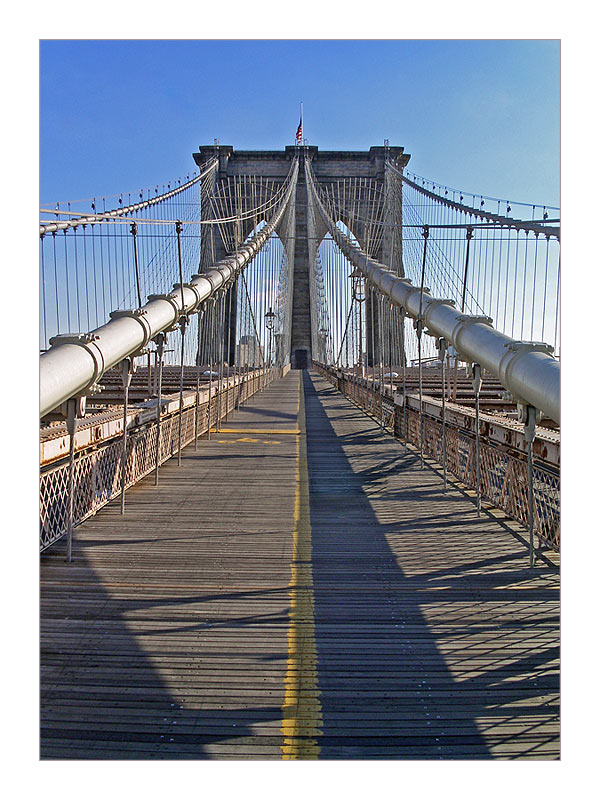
[41,372,559,759]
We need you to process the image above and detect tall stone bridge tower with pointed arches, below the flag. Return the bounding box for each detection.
[193,144,410,368]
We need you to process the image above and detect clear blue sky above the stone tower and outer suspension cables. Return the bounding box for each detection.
[40,40,560,205]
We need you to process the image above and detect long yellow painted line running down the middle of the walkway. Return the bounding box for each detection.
[281,373,323,760]
